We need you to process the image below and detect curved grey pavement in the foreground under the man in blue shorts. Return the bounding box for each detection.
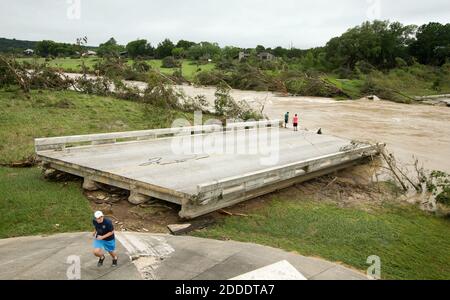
[0,233,366,280]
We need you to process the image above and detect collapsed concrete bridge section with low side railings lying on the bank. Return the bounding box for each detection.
[35,120,380,219]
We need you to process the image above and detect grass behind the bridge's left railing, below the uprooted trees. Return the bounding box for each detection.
[0,90,199,163]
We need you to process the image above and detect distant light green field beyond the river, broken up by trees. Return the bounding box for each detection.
[18,57,215,80]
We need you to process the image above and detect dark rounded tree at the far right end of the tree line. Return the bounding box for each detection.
[409,23,450,66]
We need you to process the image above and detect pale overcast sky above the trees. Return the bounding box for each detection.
[0,0,450,48]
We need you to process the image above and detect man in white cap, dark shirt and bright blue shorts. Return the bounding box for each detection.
[92,211,118,267]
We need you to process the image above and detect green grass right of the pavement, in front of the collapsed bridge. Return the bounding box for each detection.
[194,197,450,279]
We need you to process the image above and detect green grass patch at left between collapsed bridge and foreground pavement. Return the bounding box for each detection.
[0,167,92,238]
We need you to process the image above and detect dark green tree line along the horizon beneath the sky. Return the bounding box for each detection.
[5,21,450,71]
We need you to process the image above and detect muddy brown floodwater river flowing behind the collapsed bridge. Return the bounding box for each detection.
[182,86,450,173]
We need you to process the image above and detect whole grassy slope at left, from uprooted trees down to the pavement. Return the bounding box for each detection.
[0,90,203,238]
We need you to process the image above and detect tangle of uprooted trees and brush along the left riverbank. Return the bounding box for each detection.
[0,56,260,120]
